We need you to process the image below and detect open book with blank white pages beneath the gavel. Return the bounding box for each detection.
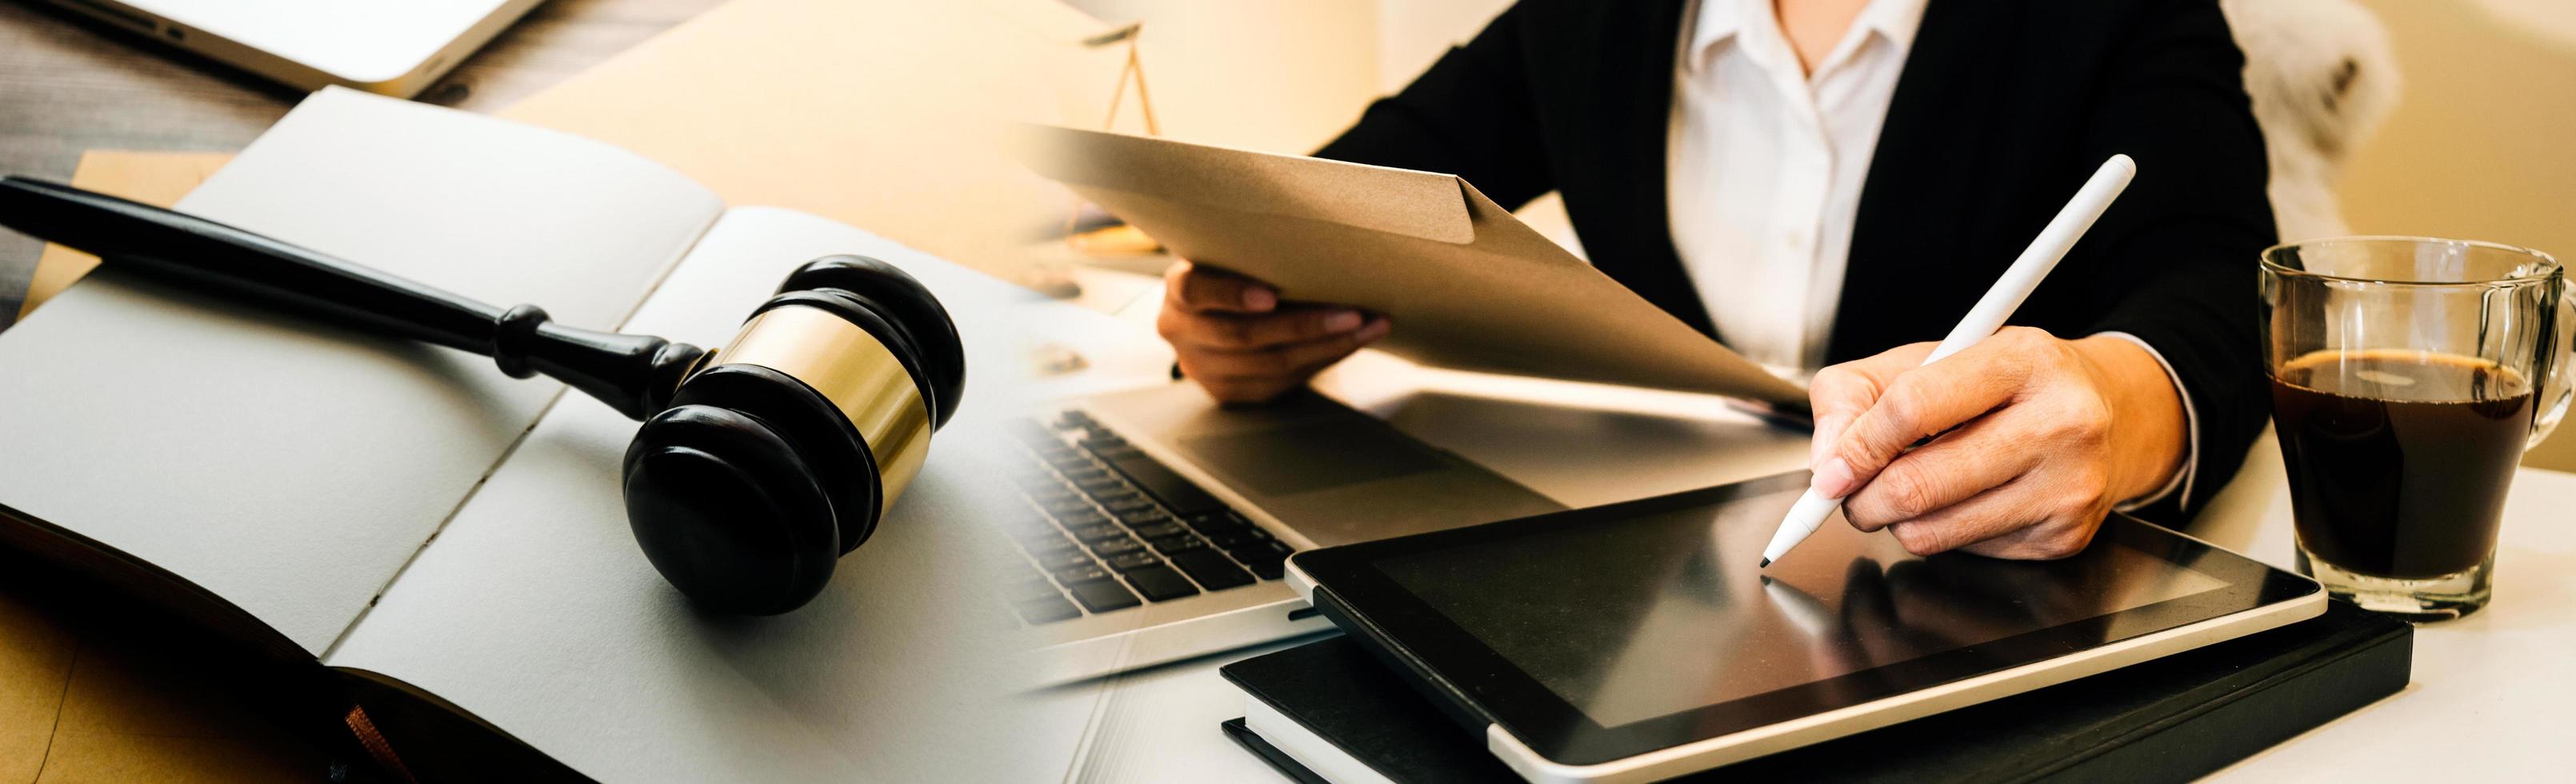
[0,90,1079,782]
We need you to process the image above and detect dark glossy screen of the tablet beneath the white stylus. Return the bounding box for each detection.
[1378,485,2226,725]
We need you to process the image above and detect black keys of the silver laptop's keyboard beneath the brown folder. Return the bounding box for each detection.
[1002,410,1288,624]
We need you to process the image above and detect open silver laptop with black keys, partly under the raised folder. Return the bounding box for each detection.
[997,382,1566,683]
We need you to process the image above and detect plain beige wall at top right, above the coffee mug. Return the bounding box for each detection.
[2342,0,2576,470]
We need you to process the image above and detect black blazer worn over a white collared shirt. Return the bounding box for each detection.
[1316,0,2274,521]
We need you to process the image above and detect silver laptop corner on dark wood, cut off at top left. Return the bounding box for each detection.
[46,0,538,98]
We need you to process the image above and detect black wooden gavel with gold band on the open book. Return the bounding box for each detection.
[0,175,966,614]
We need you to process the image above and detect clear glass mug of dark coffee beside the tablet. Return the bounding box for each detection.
[2262,238,2576,622]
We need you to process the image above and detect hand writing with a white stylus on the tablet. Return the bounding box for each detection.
[1808,327,2187,560]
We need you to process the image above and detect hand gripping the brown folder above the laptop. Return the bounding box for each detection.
[1154,261,1389,402]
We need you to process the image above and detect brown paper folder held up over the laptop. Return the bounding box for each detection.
[1012,126,1806,405]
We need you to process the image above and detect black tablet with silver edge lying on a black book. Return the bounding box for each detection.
[1288,472,2326,782]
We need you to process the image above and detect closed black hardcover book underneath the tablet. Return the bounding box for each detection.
[1221,601,2414,784]
